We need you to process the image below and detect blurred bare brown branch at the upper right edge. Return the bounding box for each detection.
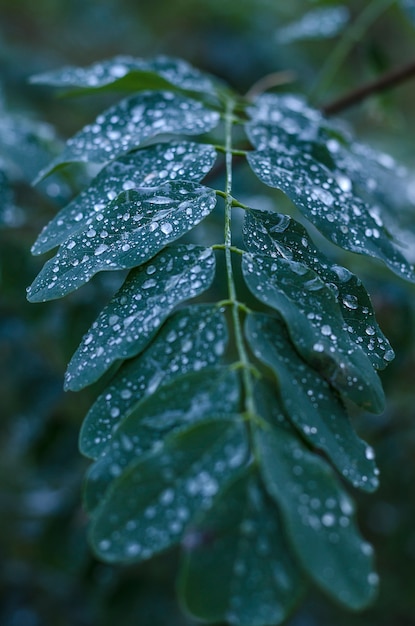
[321,61,415,115]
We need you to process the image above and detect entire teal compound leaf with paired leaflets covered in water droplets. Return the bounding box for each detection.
[29,54,414,626]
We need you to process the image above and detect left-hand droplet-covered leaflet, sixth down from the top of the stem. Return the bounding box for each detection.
[80,305,228,459]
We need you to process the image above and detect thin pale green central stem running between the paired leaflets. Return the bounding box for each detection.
[224,99,256,416]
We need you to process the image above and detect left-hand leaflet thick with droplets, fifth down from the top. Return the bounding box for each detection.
[65,245,215,390]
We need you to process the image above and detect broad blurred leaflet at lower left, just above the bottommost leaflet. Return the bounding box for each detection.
[90,416,249,562]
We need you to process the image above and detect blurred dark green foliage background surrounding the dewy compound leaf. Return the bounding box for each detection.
[0,0,415,626]
